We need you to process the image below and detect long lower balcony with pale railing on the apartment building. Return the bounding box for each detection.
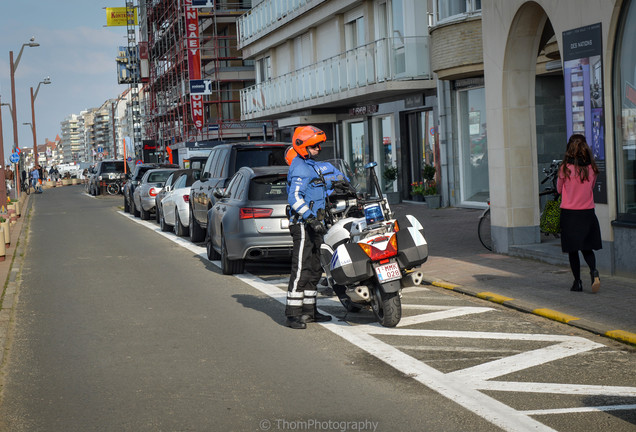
[241,36,435,120]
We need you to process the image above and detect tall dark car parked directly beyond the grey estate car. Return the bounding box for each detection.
[189,142,289,243]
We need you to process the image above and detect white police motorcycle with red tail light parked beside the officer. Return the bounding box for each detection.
[320,160,428,327]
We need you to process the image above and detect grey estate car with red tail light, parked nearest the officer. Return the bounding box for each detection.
[206,166,293,274]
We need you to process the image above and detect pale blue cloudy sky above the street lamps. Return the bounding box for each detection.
[0,0,128,161]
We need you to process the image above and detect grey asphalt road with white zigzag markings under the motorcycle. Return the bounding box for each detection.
[0,186,636,432]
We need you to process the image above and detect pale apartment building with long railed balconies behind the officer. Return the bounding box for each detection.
[239,0,441,199]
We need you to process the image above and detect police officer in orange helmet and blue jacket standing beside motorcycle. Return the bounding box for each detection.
[285,126,331,329]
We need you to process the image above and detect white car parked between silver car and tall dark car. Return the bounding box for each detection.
[157,169,201,237]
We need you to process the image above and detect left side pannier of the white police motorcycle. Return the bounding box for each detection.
[329,243,374,285]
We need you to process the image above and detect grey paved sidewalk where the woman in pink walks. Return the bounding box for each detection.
[391,201,636,344]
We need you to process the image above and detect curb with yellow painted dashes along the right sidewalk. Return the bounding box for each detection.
[422,276,636,345]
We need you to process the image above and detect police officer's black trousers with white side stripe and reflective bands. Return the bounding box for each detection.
[285,222,323,317]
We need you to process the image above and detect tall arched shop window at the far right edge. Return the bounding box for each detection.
[614,2,636,223]
